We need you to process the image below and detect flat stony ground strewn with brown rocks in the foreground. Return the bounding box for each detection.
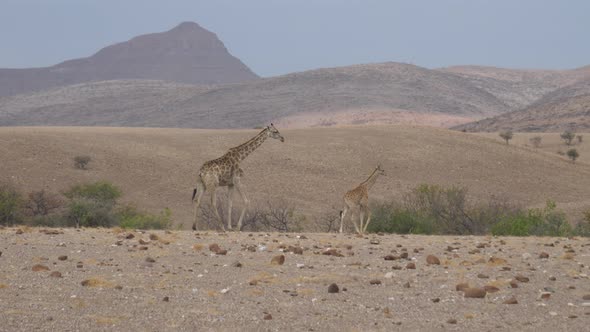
[0,228,590,331]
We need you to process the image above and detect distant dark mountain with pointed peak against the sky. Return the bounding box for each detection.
[0,22,258,96]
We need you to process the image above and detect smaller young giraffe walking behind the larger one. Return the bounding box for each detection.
[340,165,385,234]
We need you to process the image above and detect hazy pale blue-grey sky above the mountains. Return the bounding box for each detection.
[0,0,590,76]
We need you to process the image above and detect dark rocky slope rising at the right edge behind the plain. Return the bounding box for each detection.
[453,79,590,132]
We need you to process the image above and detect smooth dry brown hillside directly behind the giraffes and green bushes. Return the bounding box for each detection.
[0,126,590,227]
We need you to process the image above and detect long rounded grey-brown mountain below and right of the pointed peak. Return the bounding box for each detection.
[0,62,510,128]
